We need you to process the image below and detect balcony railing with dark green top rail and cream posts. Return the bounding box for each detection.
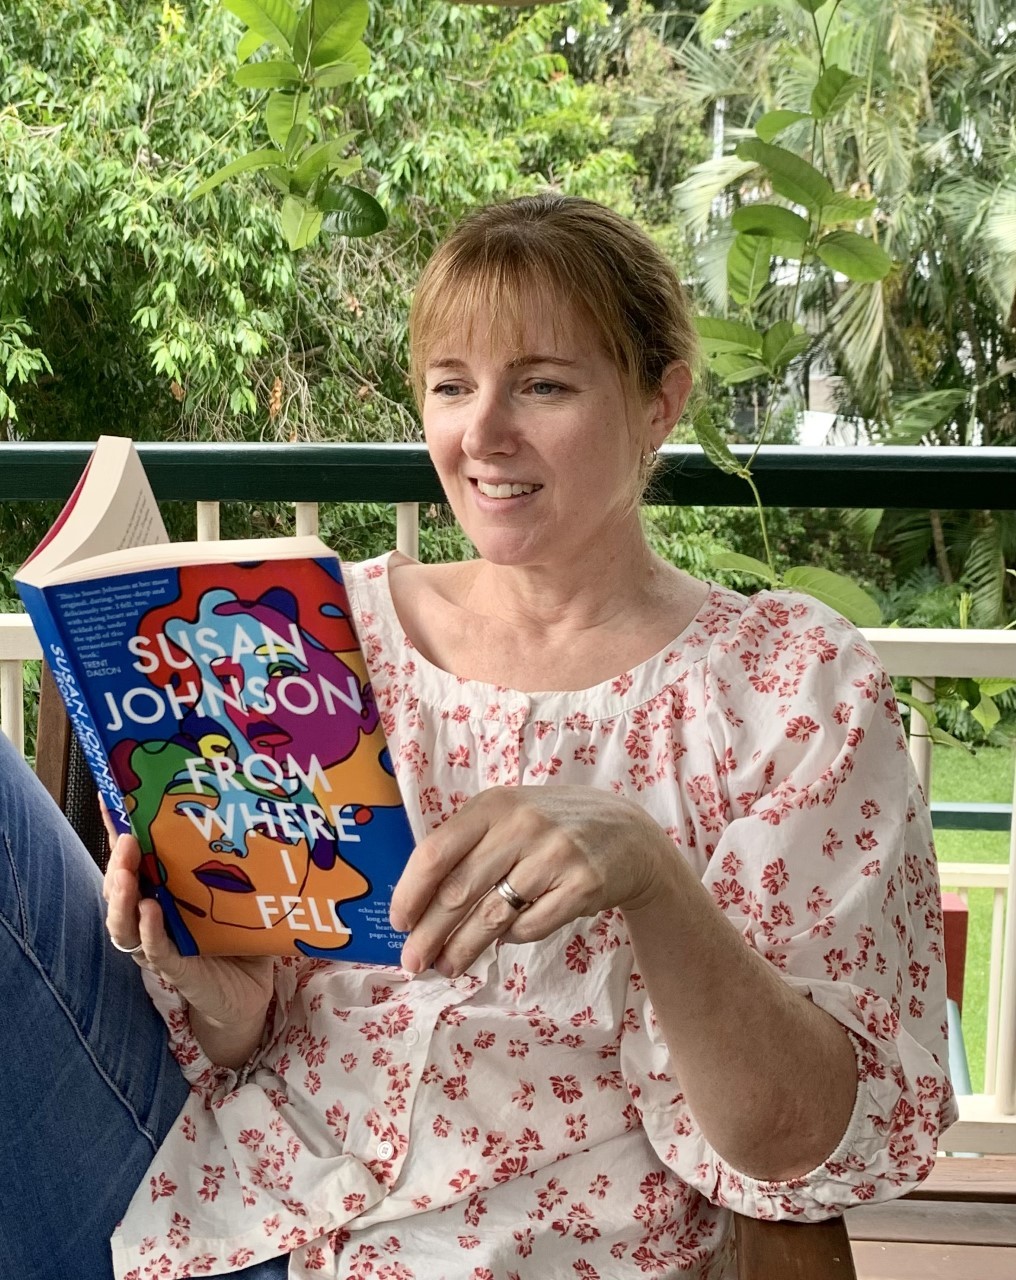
[0,443,1016,1152]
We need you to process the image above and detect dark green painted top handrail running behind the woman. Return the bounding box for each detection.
[0,442,1016,511]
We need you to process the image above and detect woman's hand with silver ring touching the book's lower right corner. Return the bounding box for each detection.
[390,786,679,978]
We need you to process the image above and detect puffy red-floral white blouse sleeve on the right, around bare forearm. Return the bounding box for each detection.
[622,593,956,1219]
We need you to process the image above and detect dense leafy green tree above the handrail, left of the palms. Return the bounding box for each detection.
[0,0,644,481]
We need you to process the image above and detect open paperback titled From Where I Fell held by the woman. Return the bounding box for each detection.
[14,436,415,964]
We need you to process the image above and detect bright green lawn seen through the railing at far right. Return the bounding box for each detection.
[932,746,1013,1092]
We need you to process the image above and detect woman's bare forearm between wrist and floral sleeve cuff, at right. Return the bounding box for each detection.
[624,864,857,1180]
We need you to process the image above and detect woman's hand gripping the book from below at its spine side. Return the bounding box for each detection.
[102,822,274,1068]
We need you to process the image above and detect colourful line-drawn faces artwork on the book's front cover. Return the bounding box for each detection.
[94,561,412,963]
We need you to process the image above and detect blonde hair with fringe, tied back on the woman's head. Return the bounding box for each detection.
[409,193,697,403]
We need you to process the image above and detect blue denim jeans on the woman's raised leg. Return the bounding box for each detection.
[0,733,288,1280]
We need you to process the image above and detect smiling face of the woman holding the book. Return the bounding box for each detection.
[424,307,665,567]
